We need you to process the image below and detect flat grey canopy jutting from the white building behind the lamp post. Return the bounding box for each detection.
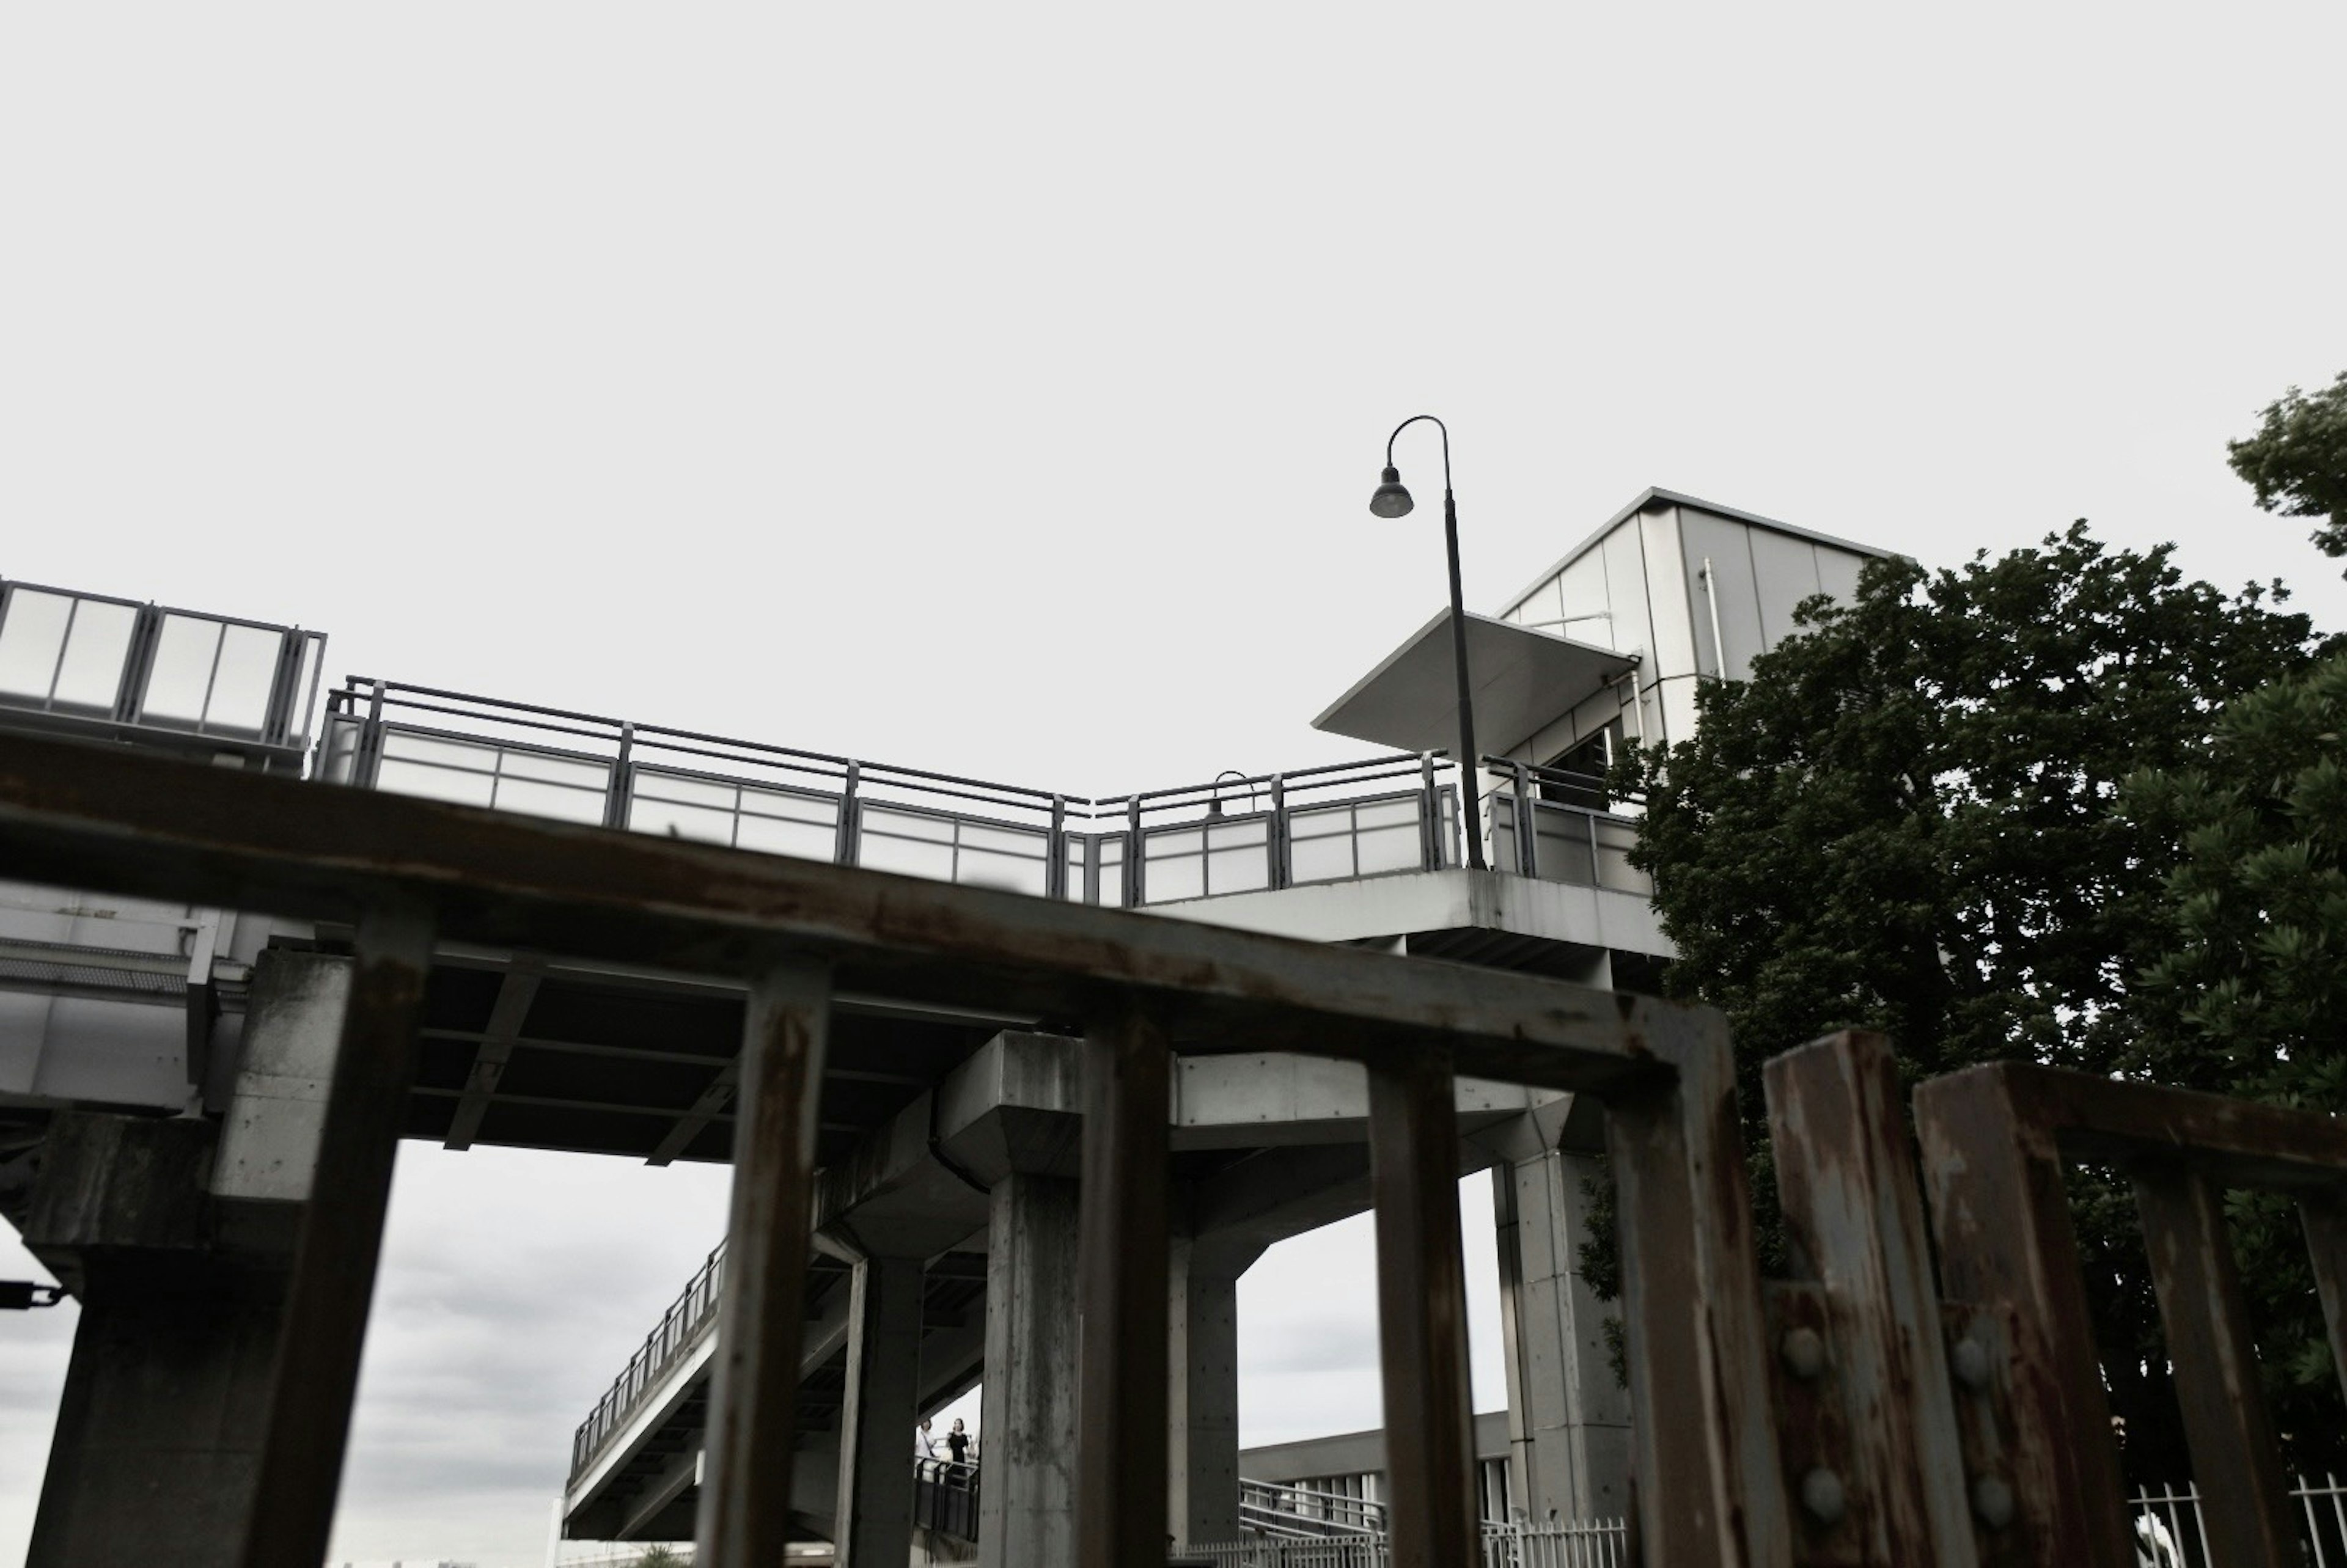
[1312,610,1638,751]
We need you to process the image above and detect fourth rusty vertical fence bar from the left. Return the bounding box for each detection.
[1368,1044,1481,1568]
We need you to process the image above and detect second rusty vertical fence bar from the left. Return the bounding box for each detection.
[695,960,831,1568]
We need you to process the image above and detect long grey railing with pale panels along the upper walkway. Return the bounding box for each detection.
[317,678,1650,909]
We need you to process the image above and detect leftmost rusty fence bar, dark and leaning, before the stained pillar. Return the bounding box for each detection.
[244,909,432,1568]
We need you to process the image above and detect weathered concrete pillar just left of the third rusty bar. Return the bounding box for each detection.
[979,1171,1078,1568]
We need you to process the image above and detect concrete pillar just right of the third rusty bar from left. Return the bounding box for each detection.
[1166,1237,1263,1547]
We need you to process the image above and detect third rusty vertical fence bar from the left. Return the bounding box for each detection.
[1075,1009,1174,1568]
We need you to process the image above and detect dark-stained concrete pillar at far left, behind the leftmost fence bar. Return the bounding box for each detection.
[23,948,350,1568]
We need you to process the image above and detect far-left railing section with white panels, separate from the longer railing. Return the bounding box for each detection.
[0,580,326,772]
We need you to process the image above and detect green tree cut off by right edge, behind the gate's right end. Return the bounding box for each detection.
[2121,655,2347,1470]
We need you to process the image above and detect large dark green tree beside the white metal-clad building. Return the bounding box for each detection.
[1592,524,2310,1474]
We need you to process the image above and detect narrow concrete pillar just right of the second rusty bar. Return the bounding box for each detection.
[831,1258,922,1568]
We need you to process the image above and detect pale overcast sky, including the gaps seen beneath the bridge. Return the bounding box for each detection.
[0,0,2347,1563]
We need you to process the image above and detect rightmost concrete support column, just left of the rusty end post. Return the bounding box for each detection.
[1493,1150,1629,1523]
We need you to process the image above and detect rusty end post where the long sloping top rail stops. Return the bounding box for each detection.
[1606,998,1793,1568]
